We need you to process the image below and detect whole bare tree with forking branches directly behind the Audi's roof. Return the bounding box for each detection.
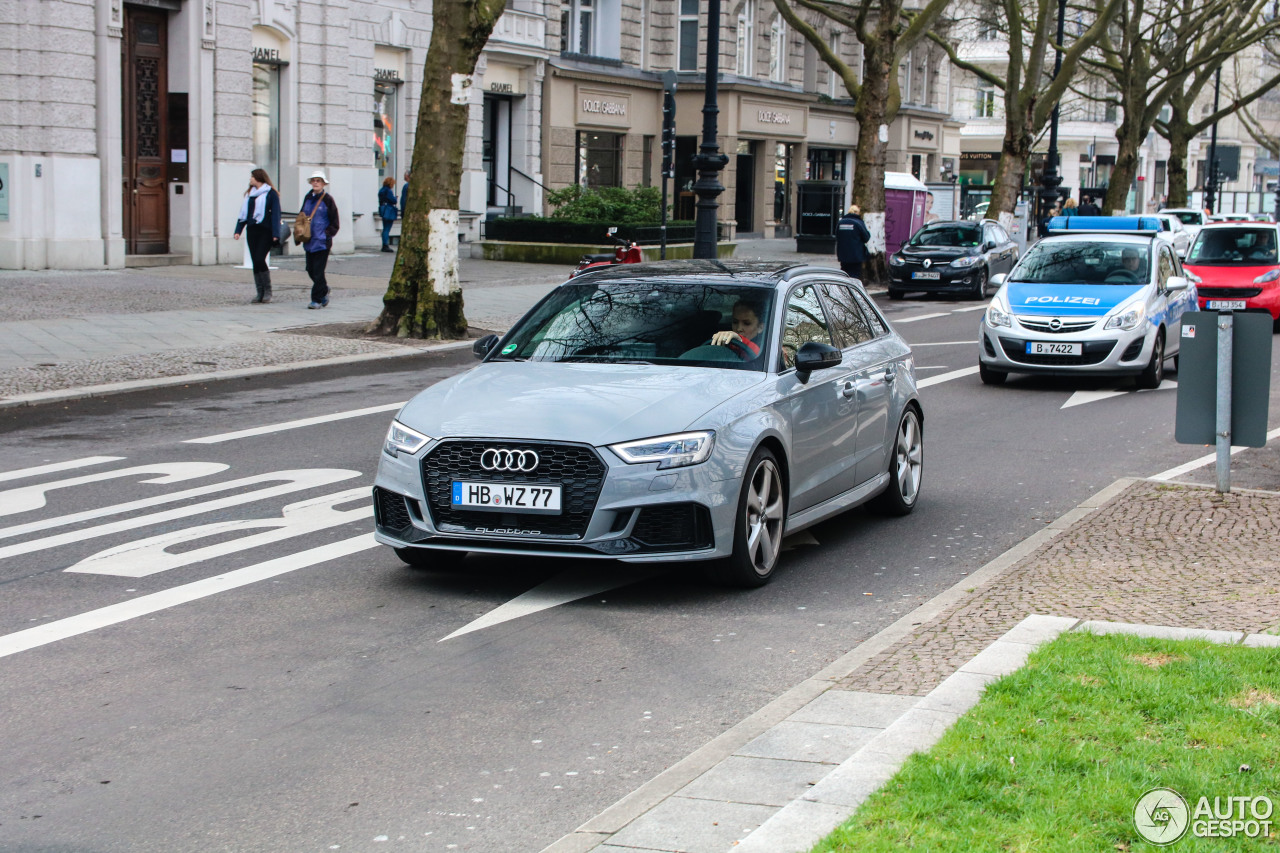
[773,0,951,280]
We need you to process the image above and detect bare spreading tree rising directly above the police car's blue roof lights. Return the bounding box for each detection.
[1083,0,1252,211]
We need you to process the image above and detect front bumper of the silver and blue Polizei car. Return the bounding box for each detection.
[978,315,1158,377]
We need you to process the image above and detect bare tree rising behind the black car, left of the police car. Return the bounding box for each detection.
[929,0,1124,228]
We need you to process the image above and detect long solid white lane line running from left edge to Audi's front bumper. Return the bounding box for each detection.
[0,533,378,657]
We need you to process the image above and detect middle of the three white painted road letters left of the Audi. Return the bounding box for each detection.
[0,467,360,560]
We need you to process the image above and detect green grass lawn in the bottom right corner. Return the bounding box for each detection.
[813,633,1280,853]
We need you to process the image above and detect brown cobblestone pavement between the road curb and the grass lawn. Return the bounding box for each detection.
[837,473,1280,695]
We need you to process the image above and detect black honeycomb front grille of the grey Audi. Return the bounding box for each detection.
[422,441,608,539]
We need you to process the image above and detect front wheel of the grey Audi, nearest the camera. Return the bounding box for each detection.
[708,447,787,589]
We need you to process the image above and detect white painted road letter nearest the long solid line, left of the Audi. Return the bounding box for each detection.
[64,487,374,578]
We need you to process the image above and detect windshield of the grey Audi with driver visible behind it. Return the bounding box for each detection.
[494,280,773,370]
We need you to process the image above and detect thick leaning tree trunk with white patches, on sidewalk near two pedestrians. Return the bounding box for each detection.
[370,0,503,338]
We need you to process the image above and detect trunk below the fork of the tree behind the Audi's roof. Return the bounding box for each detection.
[852,36,897,283]
